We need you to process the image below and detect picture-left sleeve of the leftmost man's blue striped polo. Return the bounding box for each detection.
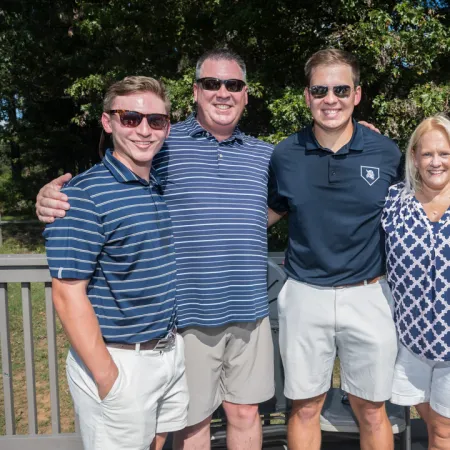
[43,186,105,280]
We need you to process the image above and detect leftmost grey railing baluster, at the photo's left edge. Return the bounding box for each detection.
[0,283,16,434]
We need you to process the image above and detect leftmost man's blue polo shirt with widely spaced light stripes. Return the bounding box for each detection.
[44,150,176,343]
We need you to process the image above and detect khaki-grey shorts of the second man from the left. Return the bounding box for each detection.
[181,317,275,425]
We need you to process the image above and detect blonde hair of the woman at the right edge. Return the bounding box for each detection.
[405,113,450,193]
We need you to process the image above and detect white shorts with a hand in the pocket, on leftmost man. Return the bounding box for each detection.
[66,335,189,450]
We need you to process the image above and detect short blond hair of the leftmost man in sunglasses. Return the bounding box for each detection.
[103,76,170,114]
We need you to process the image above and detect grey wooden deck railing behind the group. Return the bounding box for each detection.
[0,253,283,450]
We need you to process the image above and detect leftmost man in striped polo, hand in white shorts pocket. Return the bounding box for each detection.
[44,77,188,450]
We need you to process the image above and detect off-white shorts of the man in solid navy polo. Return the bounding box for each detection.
[278,279,397,401]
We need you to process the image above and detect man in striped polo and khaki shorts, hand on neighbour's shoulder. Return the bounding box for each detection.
[36,50,274,449]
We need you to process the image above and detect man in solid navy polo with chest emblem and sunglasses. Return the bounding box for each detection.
[269,49,400,450]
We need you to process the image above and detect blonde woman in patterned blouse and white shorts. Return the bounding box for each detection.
[382,114,450,449]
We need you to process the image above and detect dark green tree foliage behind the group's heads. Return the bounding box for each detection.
[0,0,450,225]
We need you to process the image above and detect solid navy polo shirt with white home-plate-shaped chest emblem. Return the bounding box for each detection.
[268,121,401,287]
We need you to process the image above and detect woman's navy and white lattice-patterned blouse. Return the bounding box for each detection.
[382,183,450,361]
